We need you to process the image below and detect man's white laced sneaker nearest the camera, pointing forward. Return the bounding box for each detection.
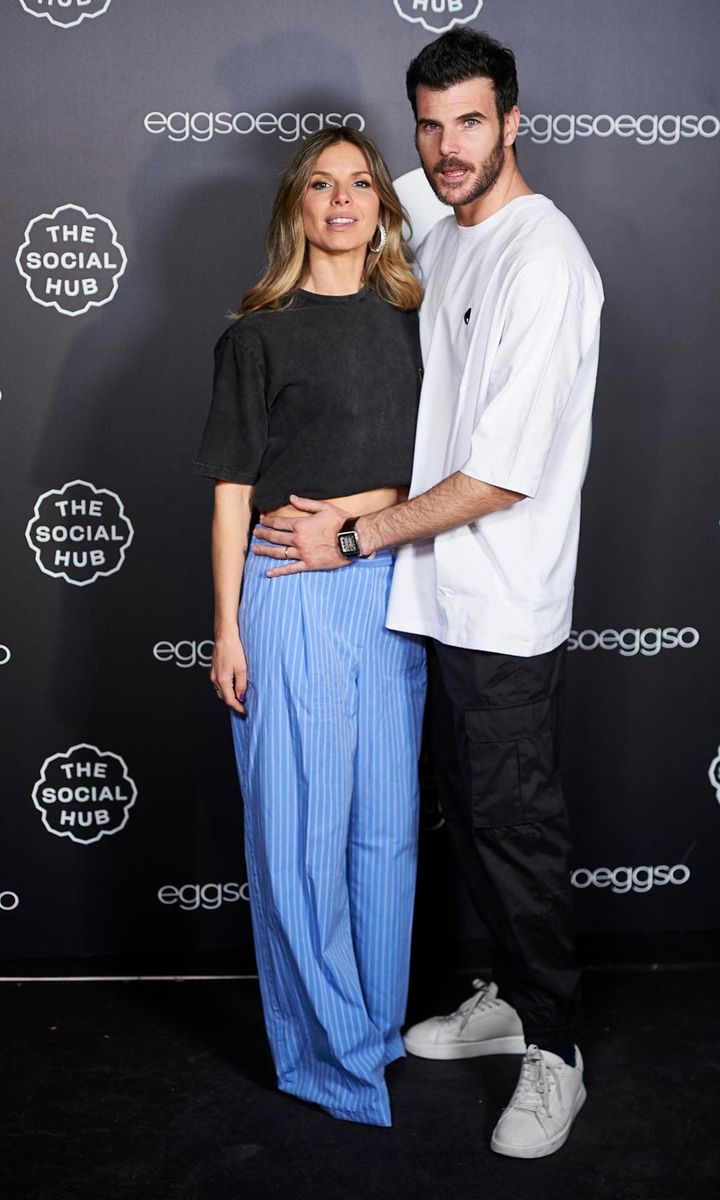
[491,1046,587,1158]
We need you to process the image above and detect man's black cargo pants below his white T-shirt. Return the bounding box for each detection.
[430,642,580,1046]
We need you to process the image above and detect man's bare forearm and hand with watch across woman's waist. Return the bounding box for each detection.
[254,470,524,575]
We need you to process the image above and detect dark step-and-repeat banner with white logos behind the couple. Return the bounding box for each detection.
[0,0,720,955]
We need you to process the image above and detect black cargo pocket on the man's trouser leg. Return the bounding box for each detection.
[464,695,564,829]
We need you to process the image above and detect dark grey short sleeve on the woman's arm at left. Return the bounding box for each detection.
[192,326,268,484]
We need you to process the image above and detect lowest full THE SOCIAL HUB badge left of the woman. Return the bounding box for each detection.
[32,743,137,845]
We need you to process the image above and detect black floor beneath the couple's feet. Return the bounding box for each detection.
[0,971,720,1200]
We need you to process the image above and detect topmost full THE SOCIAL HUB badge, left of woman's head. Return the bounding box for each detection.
[16,204,127,317]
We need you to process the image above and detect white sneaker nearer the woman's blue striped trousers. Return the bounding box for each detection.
[403,979,526,1058]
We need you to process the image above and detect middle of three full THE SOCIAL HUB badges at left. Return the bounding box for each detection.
[25,479,134,588]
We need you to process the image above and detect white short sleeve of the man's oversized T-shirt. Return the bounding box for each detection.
[460,270,601,496]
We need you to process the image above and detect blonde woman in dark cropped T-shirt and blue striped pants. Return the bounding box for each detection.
[194,127,425,1126]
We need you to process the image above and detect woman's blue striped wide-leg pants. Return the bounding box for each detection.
[233,551,425,1126]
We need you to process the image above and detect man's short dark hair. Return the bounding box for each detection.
[406,28,517,122]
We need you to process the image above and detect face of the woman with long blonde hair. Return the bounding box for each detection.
[302,142,380,254]
